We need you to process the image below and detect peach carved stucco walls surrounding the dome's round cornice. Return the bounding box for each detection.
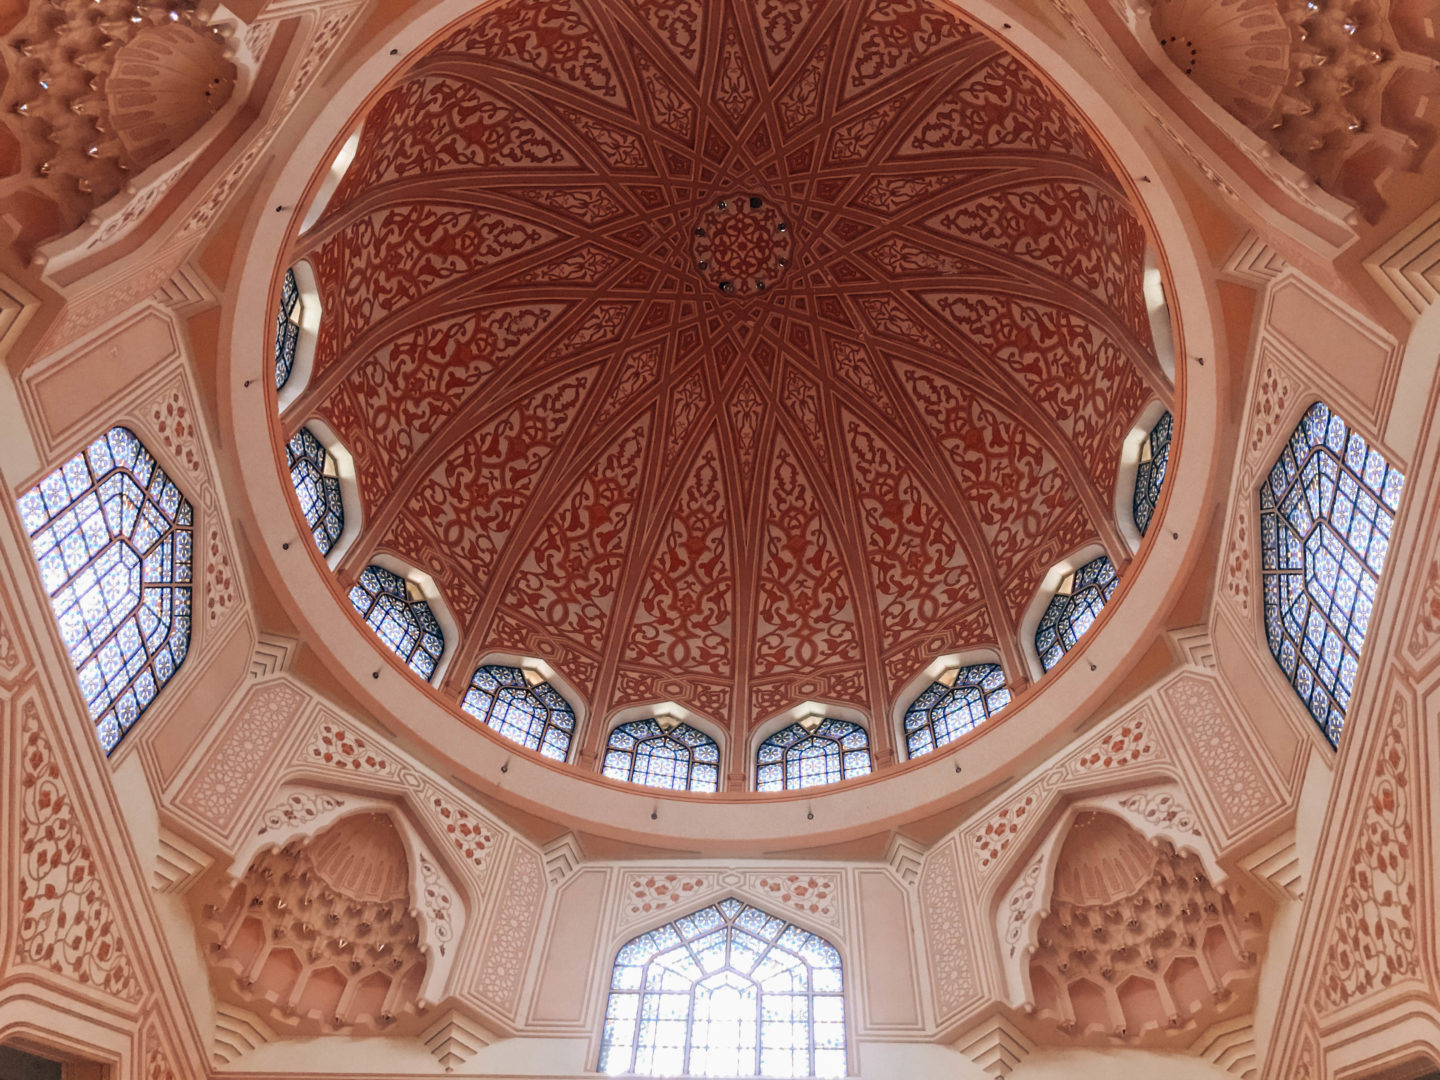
[0,3,1440,1080]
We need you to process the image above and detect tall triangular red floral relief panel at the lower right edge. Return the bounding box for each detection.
[1312,698,1426,1014]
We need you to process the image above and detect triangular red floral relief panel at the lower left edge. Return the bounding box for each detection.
[14,701,143,1002]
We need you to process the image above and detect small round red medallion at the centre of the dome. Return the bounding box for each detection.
[693,194,791,297]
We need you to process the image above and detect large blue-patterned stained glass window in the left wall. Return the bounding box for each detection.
[19,428,193,753]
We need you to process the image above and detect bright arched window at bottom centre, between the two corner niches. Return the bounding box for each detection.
[599,897,847,1077]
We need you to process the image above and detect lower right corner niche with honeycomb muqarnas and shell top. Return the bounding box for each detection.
[1028,811,1263,1045]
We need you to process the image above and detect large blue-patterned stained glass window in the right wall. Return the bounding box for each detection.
[1260,402,1405,744]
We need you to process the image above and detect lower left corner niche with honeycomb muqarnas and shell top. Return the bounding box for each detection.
[200,814,428,1035]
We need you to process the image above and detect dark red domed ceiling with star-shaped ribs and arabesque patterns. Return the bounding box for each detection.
[284,0,1171,748]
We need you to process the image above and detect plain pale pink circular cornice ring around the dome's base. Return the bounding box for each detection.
[222,3,1217,851]
